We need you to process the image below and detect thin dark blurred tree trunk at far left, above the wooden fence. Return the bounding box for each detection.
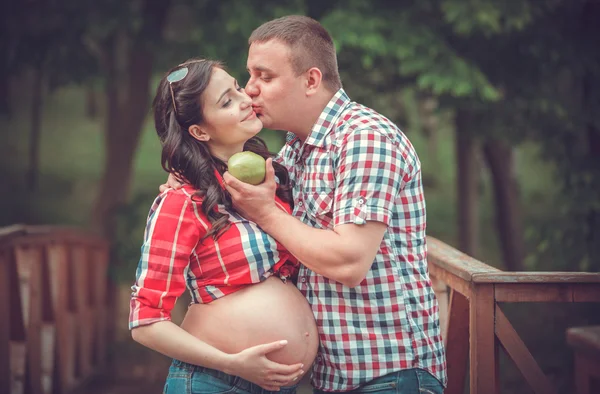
[25,64,44,192]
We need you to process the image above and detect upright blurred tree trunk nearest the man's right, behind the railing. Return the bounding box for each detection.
[455,109,479,256]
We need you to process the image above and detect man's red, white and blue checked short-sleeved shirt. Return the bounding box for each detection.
[278,90,446,391]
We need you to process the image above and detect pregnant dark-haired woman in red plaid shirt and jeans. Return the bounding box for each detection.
[129,59,318,394]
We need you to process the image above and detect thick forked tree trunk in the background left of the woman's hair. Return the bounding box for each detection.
[93,0,170,240]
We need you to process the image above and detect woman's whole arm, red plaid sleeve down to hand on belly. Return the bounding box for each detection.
[129,192,302,390]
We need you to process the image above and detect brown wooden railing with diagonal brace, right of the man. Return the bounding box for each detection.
[427,237,600,394]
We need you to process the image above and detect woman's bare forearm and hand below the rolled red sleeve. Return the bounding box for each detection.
[131,321,303,391]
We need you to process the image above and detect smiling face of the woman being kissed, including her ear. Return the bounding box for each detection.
[189,67,262,162]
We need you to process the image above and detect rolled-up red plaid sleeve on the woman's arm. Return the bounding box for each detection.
[129,190,200,329]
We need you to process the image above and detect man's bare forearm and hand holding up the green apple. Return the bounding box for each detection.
[224,159,387,287]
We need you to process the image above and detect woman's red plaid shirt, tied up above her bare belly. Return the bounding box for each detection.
[129,185,294,329]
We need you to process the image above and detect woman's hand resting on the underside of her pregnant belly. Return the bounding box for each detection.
[225,341,304,391]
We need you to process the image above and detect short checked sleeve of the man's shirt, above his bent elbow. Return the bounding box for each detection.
[333,128,412,226]
